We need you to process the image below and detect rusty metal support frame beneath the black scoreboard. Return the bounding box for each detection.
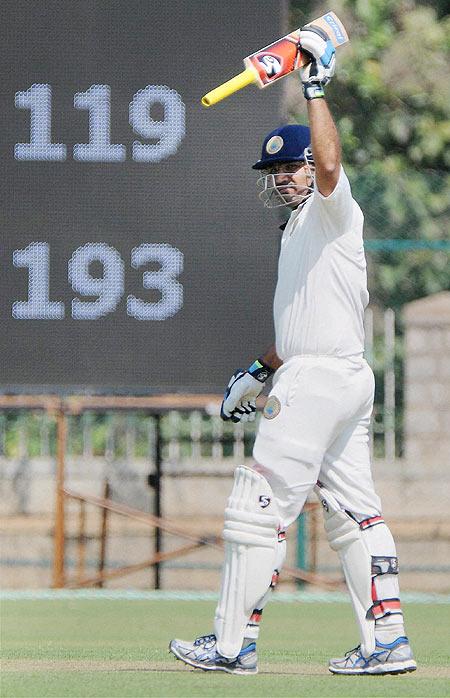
[0,395,326,589]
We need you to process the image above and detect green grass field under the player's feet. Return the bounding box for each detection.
[1,599,450,698]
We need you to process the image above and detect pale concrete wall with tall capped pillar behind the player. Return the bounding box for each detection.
[0,292,450,592]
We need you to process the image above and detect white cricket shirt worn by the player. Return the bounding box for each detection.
[274,168,369,361]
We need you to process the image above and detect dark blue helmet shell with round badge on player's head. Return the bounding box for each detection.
[252,124,311,170]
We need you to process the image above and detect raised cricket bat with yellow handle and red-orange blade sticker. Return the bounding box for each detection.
[202,12,348,107]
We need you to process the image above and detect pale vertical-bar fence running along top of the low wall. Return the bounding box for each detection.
[0,308,402,468]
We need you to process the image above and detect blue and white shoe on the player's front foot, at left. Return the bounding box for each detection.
[169,635,258,674]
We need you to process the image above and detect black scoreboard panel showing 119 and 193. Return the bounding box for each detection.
[0,0,284,393]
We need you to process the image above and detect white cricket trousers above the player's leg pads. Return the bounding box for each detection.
[253,356,381,527]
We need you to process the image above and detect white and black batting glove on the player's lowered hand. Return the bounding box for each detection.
[220,359,274,422]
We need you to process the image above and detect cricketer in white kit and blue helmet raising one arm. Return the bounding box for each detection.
[170,24,416,675]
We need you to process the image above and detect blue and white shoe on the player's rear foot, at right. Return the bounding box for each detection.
[328,637,417,674]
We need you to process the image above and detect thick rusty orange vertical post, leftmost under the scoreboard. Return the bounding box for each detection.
[53,403,67,589]
